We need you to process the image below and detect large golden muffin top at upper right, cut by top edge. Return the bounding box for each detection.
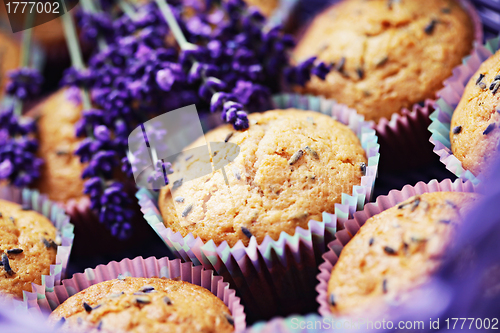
[294,0,474,121]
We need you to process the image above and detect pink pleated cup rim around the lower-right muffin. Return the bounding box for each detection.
[316,179,476,316]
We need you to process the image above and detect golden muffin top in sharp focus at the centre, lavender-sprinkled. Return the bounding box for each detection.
[159,109,367,246]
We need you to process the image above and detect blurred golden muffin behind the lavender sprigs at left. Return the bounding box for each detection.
[30,89,84,201]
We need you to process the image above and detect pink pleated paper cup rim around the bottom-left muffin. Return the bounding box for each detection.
[35,257,246,332]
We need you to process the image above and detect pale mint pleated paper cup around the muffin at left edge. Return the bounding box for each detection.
[0,186,74,308]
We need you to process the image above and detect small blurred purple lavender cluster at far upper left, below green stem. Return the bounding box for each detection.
[6,67,43,101]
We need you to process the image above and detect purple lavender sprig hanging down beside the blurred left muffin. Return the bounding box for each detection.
[63,4,133,239]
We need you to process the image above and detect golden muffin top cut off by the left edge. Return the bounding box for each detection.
[0,200,57,298]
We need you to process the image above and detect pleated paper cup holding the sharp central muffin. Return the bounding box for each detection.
[136,94,379,320]
